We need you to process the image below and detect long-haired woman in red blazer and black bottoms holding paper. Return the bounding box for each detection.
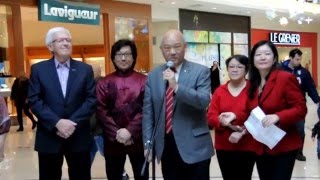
[249,40,307,180]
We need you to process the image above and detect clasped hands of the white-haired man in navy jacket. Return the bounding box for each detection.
[56,119,77,139]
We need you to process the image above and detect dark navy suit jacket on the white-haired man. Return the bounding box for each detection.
[28,58,96,153]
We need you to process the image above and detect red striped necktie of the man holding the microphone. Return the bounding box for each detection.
[166,86,173,134]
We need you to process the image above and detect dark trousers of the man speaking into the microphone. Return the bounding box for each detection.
[161,133,211,180]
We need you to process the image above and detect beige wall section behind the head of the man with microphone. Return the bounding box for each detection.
[152,21,178,67]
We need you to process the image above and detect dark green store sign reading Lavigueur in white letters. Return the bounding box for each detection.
[38,0,100,25]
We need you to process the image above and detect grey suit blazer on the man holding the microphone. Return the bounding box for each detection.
[142,60,214,164]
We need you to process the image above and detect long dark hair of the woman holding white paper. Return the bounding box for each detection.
[248,40,279,99]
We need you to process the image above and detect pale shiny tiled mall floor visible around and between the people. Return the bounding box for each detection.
[0,97,320,180]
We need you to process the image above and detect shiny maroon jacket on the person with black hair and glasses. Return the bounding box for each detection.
[96,71,147,153]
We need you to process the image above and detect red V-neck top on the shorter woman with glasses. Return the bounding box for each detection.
[208,82,262,153]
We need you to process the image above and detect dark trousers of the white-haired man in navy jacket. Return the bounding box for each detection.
[38,152,91,180]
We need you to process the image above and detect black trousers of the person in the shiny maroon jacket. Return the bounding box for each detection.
[104,150,149,180]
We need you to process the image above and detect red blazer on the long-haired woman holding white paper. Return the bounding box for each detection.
[256,70,307,154]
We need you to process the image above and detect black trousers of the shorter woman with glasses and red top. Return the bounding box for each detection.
[216,150,257,180]
